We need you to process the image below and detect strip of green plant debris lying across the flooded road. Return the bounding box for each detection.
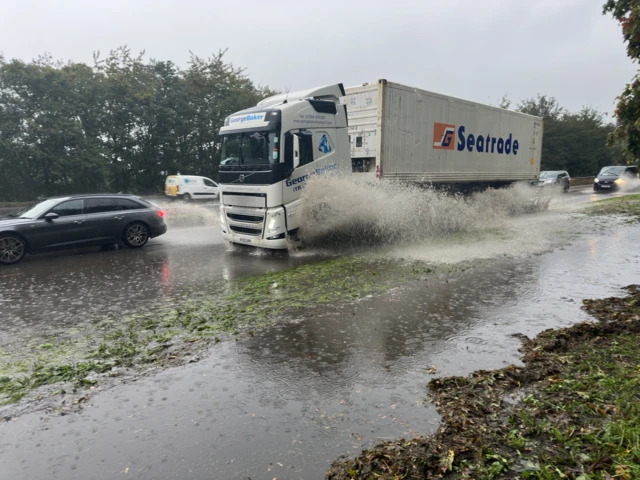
[0,255,440,405]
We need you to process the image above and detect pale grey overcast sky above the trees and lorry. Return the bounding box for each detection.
[0,0,635,112]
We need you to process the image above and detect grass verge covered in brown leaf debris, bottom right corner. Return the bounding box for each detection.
[326,285,640,480]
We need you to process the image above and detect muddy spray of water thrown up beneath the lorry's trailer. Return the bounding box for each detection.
[299,176,556,248]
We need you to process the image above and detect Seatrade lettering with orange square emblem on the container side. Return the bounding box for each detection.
[433,122,520,155]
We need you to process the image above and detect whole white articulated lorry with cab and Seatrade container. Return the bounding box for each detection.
[219,80,542,249]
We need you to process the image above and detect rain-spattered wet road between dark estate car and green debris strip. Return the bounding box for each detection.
[0,221,328,348]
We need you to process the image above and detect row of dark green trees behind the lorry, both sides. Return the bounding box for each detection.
[0,47,622,201]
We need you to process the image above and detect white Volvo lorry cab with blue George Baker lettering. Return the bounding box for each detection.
[219,84,351,249]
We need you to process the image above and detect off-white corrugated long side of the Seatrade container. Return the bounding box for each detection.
[378,81,542,182]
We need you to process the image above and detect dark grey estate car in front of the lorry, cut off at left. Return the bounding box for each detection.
[0,195,167,265]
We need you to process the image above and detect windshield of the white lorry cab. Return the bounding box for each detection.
[220,132,280,165]
